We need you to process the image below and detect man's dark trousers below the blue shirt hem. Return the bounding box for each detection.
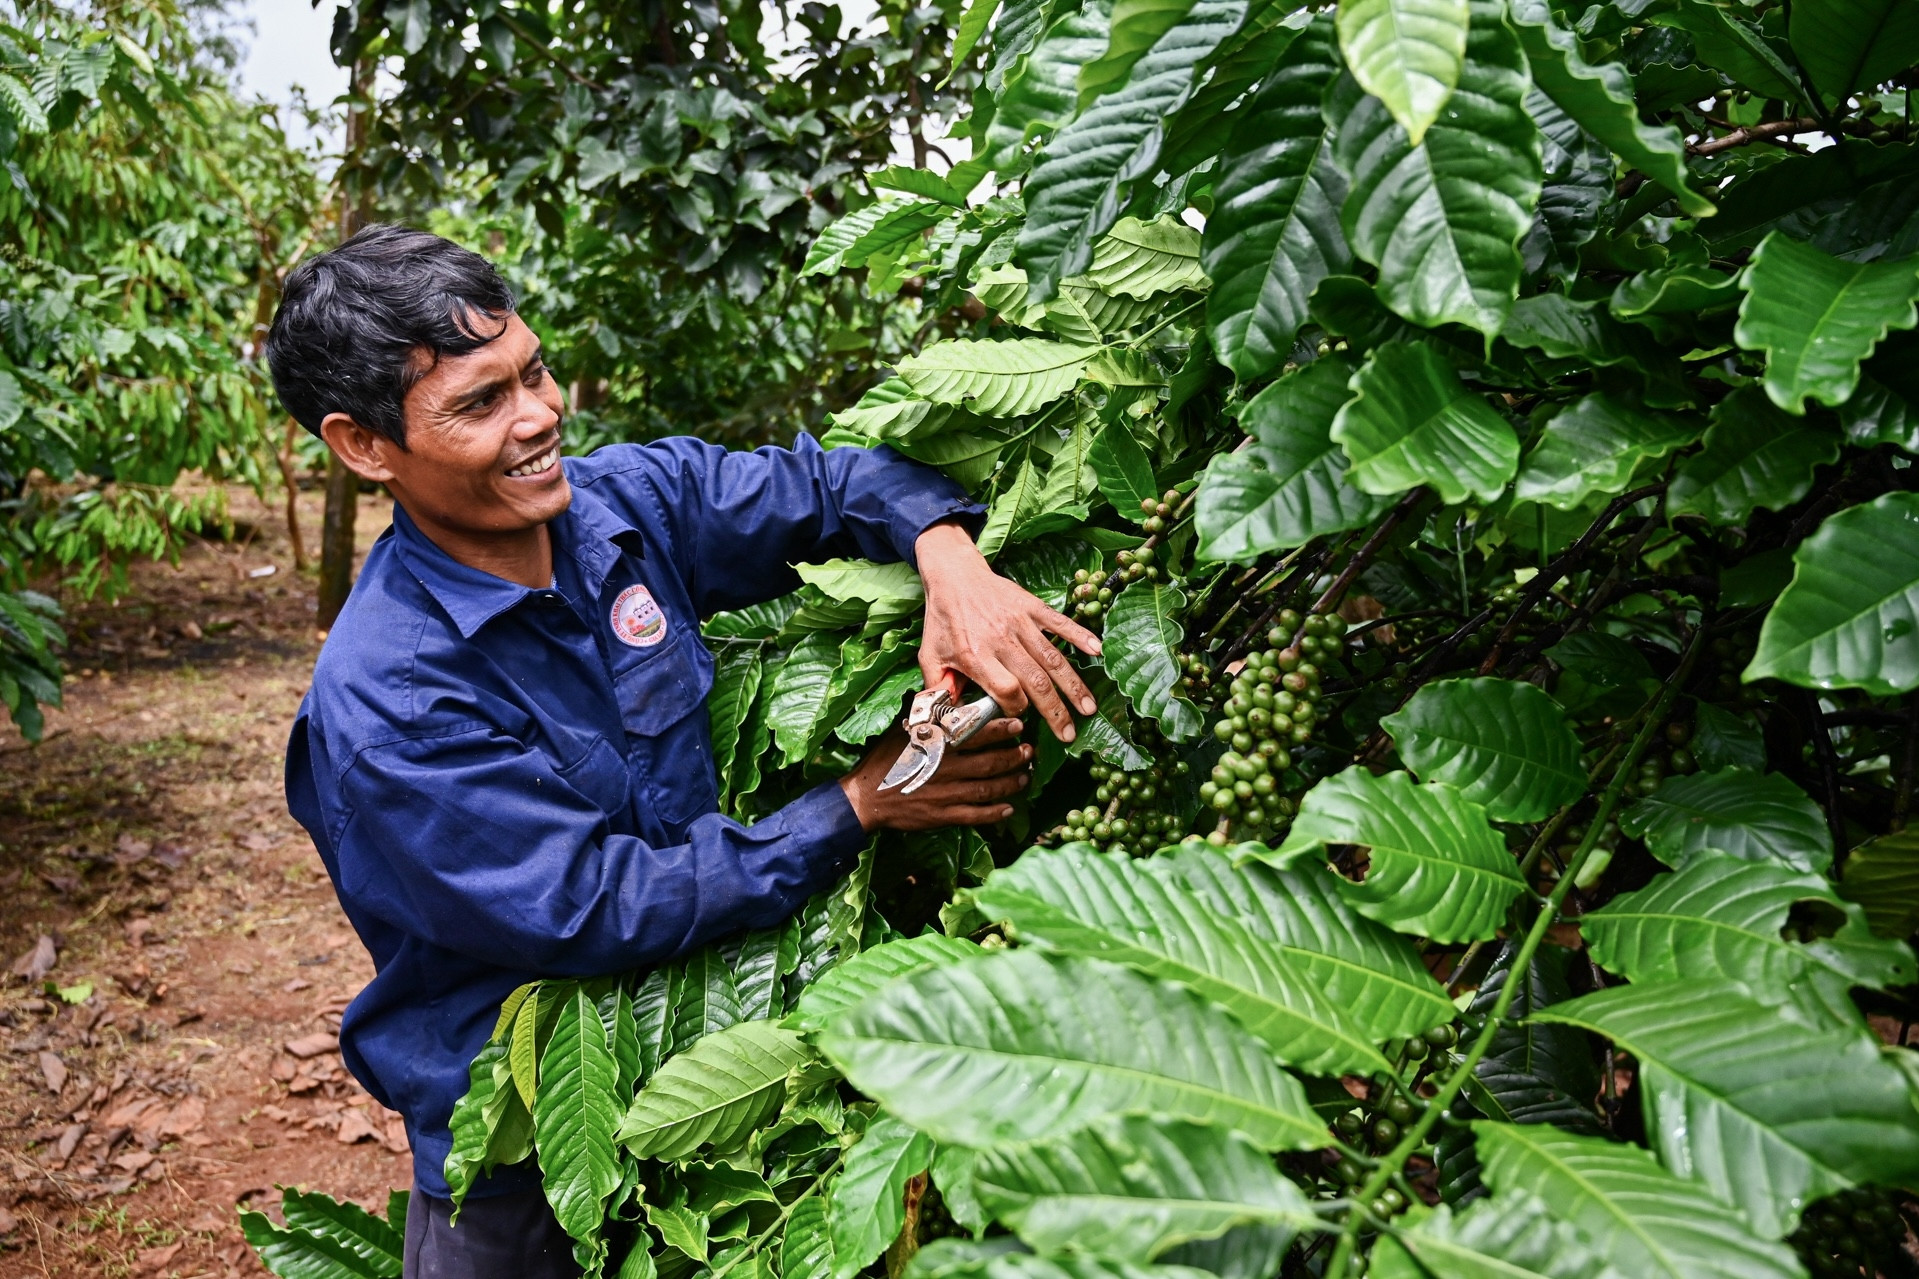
[401,1187,580,1279]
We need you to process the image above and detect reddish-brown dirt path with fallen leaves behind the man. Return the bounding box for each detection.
[0,483,411,1279]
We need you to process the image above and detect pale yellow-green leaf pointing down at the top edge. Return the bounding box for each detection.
[1339,0,1472,146]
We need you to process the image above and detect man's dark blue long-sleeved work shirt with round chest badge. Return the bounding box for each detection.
[286,436,981,1196]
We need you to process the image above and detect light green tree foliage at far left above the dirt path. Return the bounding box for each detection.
[0,0,320,737]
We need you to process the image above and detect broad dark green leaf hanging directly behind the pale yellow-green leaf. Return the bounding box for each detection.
[1328,0,1545,336]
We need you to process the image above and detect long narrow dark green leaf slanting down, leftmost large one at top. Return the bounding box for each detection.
[1017,0,1247,302]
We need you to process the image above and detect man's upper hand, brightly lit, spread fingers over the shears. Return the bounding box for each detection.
[913,522,1100,741]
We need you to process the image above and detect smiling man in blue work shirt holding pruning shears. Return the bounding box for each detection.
[267,227,1098,1279]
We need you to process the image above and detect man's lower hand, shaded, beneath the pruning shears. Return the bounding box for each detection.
[841,720,1032,832]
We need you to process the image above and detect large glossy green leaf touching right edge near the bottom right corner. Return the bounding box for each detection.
[1533,981,1919,1239]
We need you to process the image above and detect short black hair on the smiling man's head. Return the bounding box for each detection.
[267,225,514,447]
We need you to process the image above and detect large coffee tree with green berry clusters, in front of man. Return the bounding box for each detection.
[248,0,1919,1279]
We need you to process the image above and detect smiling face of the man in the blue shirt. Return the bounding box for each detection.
[382,315,574,536]
